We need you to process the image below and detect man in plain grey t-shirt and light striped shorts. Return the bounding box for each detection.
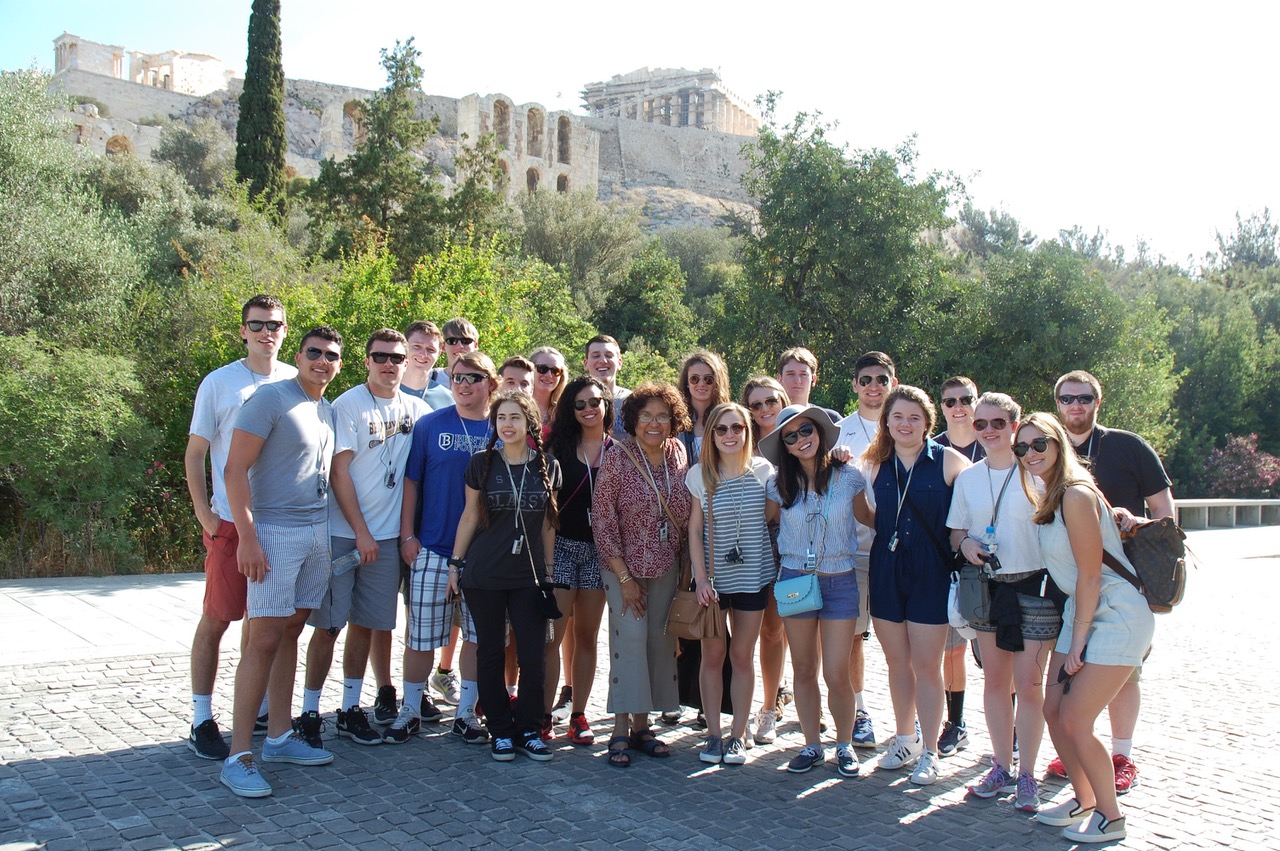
[221,325,342,797]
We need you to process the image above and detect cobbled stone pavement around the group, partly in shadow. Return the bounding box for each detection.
[0,529,1280,851]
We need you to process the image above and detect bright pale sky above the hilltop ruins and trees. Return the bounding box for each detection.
[0,0,1280,264]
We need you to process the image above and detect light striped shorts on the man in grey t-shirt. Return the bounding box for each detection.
[248,523,333,618]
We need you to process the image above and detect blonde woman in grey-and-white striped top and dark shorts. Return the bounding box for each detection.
[687,402,777,765]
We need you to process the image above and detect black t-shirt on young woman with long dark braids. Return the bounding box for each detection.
[460,449,561,591]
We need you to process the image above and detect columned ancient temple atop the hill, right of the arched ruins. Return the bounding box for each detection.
[582,68,760,136]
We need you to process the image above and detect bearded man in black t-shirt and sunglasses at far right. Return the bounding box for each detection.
[1048,370,1174,795]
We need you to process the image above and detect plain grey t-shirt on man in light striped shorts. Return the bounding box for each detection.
[236,380,334,527]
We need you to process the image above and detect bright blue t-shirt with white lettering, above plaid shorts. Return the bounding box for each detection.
[404,407,489,558]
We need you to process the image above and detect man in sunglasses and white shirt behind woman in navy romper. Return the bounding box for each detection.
[840,352,897,747]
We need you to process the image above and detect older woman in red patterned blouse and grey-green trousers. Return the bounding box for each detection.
[591,381,690,768]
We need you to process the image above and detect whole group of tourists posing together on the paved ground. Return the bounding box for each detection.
[186,296,1172,842]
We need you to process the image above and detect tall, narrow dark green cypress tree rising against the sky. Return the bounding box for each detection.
[236,0,285,218]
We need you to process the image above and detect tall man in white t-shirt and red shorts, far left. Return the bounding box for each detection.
[184,296,298,759]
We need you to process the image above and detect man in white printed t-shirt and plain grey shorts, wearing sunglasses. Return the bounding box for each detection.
[296,328,431,747]
